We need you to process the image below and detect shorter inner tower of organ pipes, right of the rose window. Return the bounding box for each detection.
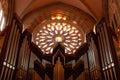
[87,32,102,80]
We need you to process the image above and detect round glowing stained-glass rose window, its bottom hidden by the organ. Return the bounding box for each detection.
[35,22,81,54]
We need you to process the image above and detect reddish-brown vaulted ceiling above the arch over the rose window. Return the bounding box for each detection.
[15,0,103,20]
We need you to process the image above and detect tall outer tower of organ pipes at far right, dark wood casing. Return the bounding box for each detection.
[96,20,119,80]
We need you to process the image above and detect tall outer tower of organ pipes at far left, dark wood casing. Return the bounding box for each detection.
[0,16,22,80]
